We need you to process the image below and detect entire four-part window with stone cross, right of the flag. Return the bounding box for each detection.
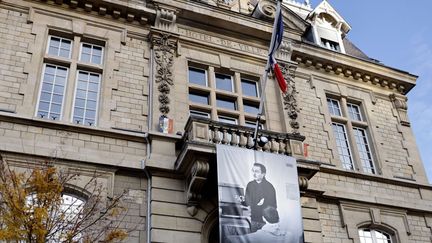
[327,98,376,174]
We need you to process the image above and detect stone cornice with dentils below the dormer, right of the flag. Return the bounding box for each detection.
[292,43,417,95]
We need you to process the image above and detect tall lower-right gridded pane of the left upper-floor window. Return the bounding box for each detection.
[73,71,100,126]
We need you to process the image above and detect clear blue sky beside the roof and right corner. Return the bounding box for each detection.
[308,0,432,183]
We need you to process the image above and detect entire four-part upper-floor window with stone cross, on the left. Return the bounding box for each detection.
[36,35,104,126]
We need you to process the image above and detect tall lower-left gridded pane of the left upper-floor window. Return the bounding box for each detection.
[37,65,67,120]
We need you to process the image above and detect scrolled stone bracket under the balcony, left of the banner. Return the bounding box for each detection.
[187,160,210,216]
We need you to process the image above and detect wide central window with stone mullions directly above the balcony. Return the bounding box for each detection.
[187,63,265,127]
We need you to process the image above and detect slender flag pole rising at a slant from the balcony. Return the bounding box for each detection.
[254,0,281,144]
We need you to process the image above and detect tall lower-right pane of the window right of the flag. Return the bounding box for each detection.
[353,127,375,174]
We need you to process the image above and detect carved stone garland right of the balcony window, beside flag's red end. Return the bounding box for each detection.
[280,62,300,133]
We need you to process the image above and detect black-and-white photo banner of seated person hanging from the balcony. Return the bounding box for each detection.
[216,145,304,243]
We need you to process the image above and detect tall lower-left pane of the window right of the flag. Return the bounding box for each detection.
[332,123,354,170]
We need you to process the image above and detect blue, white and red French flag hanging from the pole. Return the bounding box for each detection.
[268,1,288,93]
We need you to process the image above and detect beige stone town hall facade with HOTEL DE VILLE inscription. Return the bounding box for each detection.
[0,0,432,243]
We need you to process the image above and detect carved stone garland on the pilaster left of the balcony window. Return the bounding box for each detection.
[152,33,177,115]
